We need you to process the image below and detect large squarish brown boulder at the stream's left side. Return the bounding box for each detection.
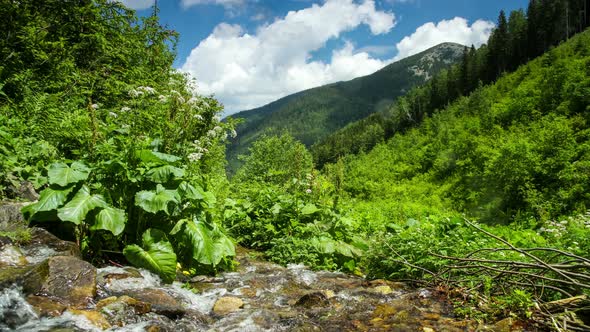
[41,256,96,308]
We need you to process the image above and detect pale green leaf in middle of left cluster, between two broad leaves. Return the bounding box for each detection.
[57,185,107,225]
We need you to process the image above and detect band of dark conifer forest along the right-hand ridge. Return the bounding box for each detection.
[312,0,588,167]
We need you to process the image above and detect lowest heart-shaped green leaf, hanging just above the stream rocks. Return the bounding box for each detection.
[123,228,176,283]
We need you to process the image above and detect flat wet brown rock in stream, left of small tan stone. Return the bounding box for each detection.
[125,288,186,319]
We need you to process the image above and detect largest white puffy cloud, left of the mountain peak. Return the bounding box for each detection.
[182,0,395,114]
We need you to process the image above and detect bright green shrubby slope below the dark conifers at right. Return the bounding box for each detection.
[345,31,590,223]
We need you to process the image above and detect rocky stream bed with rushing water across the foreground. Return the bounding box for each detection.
[0,229,528,332]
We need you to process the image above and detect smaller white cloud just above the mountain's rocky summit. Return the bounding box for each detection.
[394,17,494,60]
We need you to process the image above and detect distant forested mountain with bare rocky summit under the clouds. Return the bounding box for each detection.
[227,43,464,170]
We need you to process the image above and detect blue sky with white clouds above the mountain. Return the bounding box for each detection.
[119,0,528,115]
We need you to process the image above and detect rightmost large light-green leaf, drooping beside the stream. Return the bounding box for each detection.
[170,219,236,266]
